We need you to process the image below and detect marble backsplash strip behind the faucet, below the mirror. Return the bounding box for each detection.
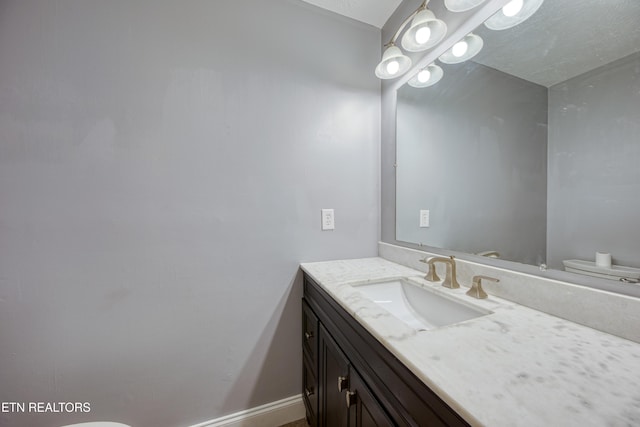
[378,242,640,343]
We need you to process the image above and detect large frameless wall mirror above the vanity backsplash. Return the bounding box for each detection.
[396,0,640,286]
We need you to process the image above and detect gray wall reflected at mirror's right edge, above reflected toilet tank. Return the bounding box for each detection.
[547,54,640,268]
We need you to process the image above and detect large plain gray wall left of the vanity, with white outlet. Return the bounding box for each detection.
[0,0,380,427]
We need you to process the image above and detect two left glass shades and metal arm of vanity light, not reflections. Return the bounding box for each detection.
[376,0,447,79]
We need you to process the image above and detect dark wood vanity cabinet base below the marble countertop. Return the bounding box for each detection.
[302,274,469,427]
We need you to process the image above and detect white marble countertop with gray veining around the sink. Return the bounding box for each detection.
[301,258,640,427]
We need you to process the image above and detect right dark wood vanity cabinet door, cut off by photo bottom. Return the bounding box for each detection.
[345,369,395,427]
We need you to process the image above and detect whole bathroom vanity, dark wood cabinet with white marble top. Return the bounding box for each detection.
[302,258,640,427]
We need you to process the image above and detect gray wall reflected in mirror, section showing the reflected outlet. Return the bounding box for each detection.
[396,61,547,264]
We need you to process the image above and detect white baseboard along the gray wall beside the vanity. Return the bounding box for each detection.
[191,394,305,427]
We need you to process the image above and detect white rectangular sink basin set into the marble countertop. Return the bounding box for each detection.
[352,279,491,330]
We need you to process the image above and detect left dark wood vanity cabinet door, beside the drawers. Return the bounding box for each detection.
[318,324,349,427]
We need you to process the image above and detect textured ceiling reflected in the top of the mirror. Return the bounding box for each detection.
[473,0,640,87]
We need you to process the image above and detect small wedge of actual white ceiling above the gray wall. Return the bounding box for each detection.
[302,0,402,28]
